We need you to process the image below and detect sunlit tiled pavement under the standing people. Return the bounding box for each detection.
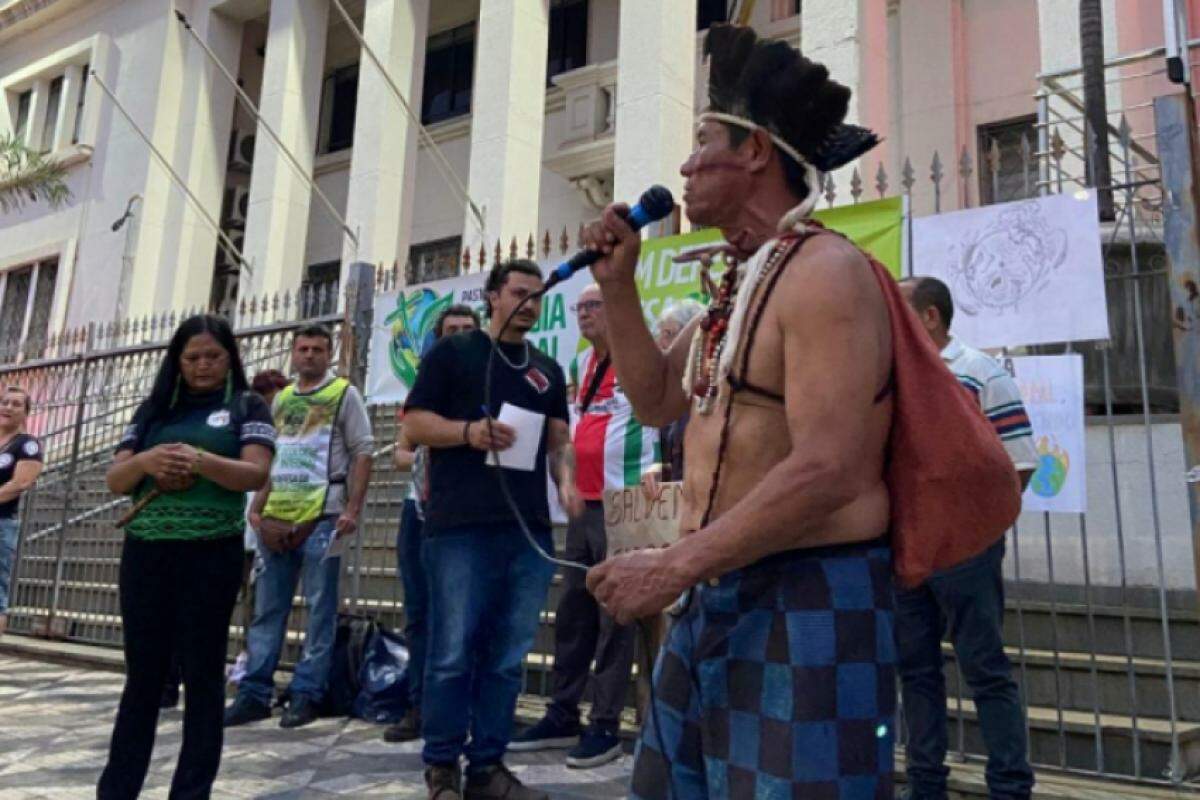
[0,655,632,800]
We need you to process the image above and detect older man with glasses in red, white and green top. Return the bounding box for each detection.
[509,285,659,769]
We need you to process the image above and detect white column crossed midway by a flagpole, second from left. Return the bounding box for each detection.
[239,0,329,297]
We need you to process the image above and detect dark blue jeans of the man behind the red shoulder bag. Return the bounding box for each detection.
[895,540,1033,800]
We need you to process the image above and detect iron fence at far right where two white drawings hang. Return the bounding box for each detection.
[913,59,1185,783]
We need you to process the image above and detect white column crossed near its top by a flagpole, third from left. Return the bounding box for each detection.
[342,0,430,278]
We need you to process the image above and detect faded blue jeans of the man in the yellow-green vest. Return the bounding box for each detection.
[238,518,341,703]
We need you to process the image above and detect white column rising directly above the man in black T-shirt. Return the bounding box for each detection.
[463,0,550,260]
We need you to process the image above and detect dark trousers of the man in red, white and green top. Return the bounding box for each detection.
[547,500,636,733]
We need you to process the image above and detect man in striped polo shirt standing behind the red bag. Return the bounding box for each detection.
[895,277,1038,800]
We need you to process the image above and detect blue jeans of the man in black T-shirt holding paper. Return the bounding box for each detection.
[421,523,554,770]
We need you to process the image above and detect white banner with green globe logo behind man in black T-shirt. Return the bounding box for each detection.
[367,264,592,404]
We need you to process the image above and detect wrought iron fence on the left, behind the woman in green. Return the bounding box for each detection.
[0,297,341,644]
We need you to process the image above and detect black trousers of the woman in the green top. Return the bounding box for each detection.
[97,531,242,800]
